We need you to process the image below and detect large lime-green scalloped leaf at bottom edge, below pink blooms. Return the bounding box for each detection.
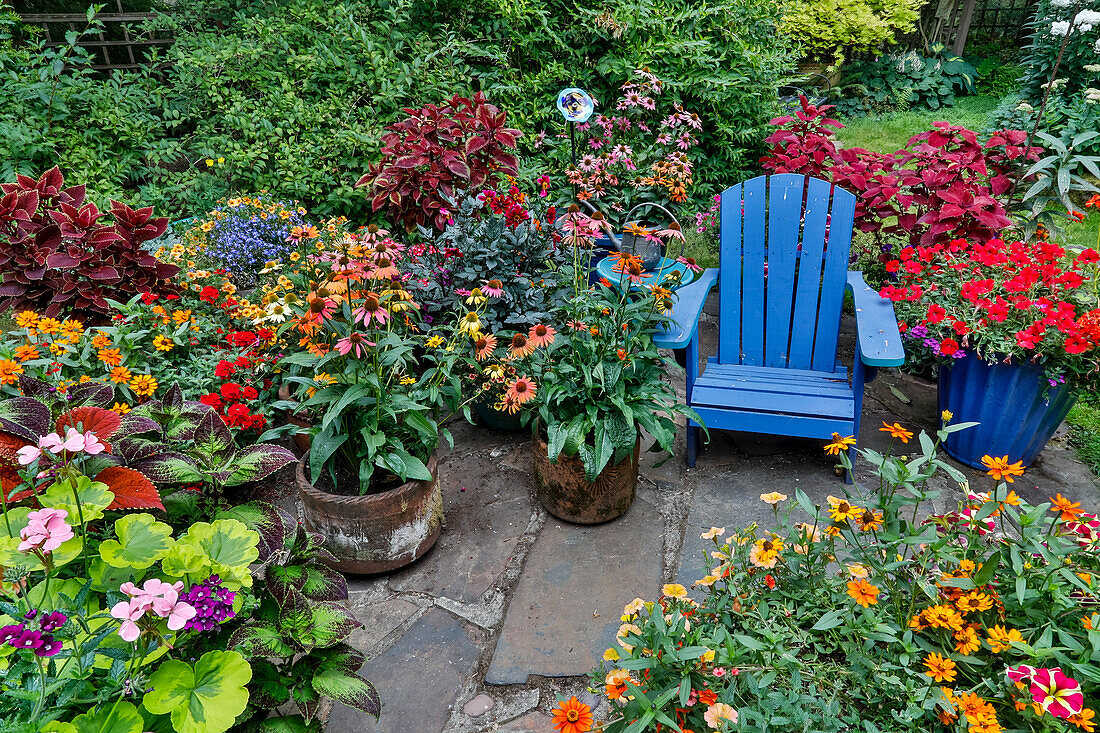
[138,652,252,733]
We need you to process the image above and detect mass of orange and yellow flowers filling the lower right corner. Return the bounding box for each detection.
[591,422,1100,733]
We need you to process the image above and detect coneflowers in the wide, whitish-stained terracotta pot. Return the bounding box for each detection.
[261,226,487,573]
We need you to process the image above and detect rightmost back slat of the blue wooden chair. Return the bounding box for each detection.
[813,180,856,371]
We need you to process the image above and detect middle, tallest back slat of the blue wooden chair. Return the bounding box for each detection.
[763,174,806,368]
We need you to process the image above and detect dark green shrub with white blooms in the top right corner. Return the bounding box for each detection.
[1020,0,1100,102]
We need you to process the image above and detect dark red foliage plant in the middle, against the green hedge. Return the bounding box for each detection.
[355,91,521,231]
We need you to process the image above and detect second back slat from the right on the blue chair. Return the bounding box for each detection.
[790,178,833,369]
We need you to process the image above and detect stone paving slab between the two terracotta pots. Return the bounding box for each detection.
[389,442,536,603]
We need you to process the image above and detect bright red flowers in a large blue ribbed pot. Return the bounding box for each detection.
[881,239,1100,468]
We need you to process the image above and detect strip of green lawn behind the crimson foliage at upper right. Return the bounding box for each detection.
[836,96,1001,153]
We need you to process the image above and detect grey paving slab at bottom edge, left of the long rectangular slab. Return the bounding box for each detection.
[328,609,482,733]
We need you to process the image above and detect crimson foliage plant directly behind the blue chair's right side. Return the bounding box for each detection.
[760,97,1040,247]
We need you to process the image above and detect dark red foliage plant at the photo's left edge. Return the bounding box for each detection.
[0,167,179,322]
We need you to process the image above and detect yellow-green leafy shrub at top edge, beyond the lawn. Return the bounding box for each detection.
[780,0,925,62]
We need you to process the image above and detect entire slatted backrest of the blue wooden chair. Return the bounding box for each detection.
[718,174,856,372]
